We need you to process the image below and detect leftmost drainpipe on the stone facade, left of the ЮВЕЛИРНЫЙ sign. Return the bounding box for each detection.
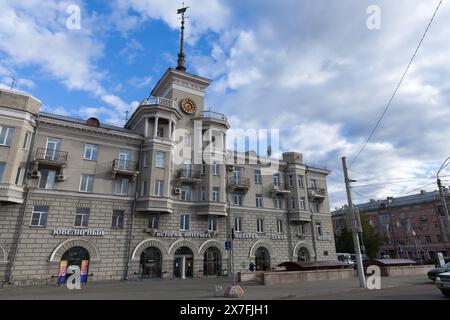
[6,117,39,284]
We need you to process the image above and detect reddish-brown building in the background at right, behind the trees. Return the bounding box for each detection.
[332,189,450,261]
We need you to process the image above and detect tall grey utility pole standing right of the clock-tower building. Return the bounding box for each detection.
[342,157,366,288]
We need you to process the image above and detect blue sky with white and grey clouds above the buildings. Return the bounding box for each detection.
[0,0,450,209]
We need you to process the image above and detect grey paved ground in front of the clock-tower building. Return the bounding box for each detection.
[0,275,443,300]
